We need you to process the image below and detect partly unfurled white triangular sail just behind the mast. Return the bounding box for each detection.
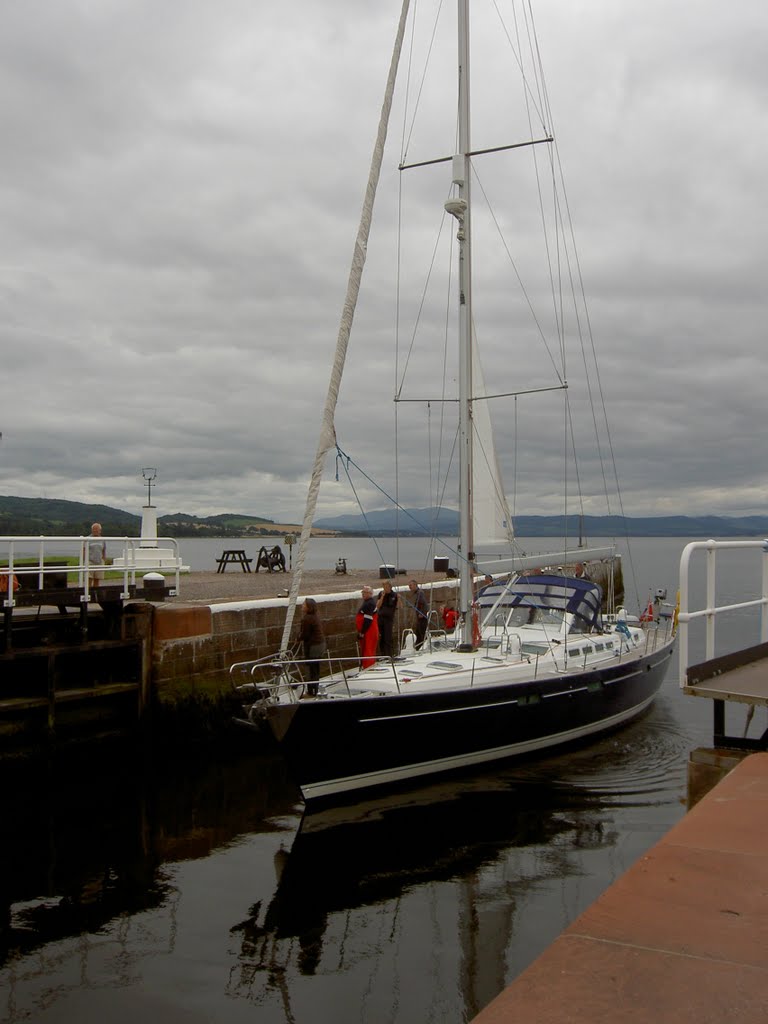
[472,338,514,550]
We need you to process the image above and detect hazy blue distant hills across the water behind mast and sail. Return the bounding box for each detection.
[315,508,768,538]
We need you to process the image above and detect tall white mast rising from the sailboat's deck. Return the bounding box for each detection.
[445,0,475,648]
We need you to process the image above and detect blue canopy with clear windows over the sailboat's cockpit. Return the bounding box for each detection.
[477,572,602,633]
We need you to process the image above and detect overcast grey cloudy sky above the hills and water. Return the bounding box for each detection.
[0,0,768,522]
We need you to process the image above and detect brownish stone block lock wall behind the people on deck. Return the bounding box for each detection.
[152,581,457,705]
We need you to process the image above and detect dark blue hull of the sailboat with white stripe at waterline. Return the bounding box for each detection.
[257,644,673,801]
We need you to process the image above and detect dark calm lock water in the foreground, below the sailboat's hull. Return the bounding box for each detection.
[0,697,689,1024]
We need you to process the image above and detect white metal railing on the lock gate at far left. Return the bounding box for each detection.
[0,536,181,607]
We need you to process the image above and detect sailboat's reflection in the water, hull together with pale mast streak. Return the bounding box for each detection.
[232,775,616,1007]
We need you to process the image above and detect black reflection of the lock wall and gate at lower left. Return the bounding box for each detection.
[0,752,296,963]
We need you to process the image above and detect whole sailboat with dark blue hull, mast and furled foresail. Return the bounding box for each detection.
[232,0,675,802]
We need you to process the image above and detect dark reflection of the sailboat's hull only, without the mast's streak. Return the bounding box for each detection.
[232,775,616,987]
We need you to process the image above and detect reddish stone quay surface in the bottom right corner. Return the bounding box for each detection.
[473,753,768,1024]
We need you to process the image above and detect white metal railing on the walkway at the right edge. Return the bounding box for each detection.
[678,540,768,687]
